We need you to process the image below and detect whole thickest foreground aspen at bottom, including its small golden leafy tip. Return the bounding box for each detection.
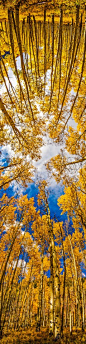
[38,181,61,338]
